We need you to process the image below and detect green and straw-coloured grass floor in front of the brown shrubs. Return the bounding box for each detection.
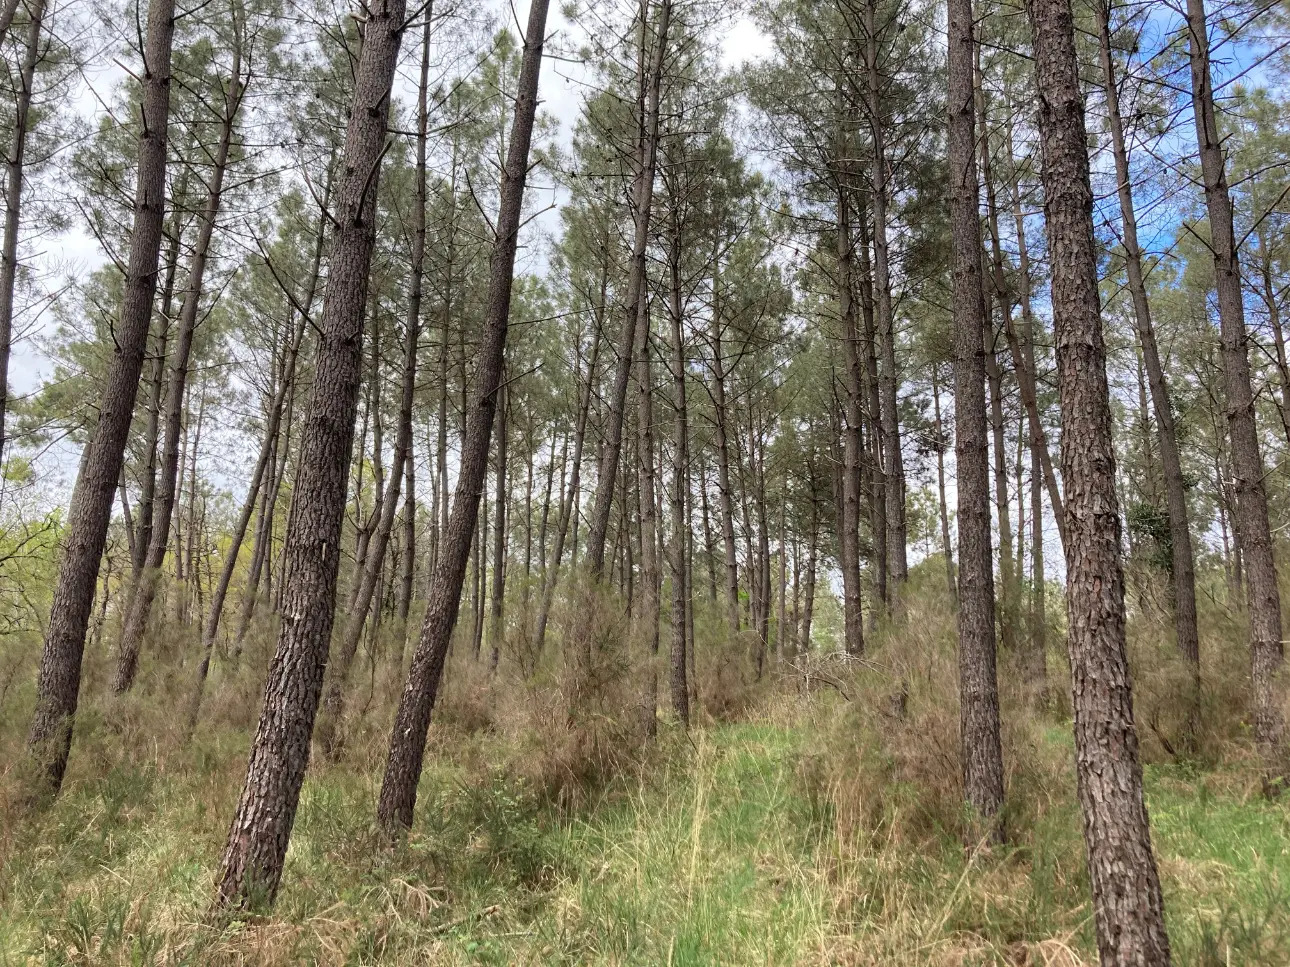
[0,675,1290,966]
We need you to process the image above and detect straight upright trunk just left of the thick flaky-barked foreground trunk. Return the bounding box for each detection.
[948,0,1004,834]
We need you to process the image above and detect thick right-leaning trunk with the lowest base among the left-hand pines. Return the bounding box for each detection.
[215,0,405,908]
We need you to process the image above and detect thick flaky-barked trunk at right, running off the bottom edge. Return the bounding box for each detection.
[1026,0,1169,967]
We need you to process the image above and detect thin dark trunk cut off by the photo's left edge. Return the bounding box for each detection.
[0,0,45,465]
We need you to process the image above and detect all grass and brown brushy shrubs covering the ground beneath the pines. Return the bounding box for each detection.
[0,572,1290,967]
